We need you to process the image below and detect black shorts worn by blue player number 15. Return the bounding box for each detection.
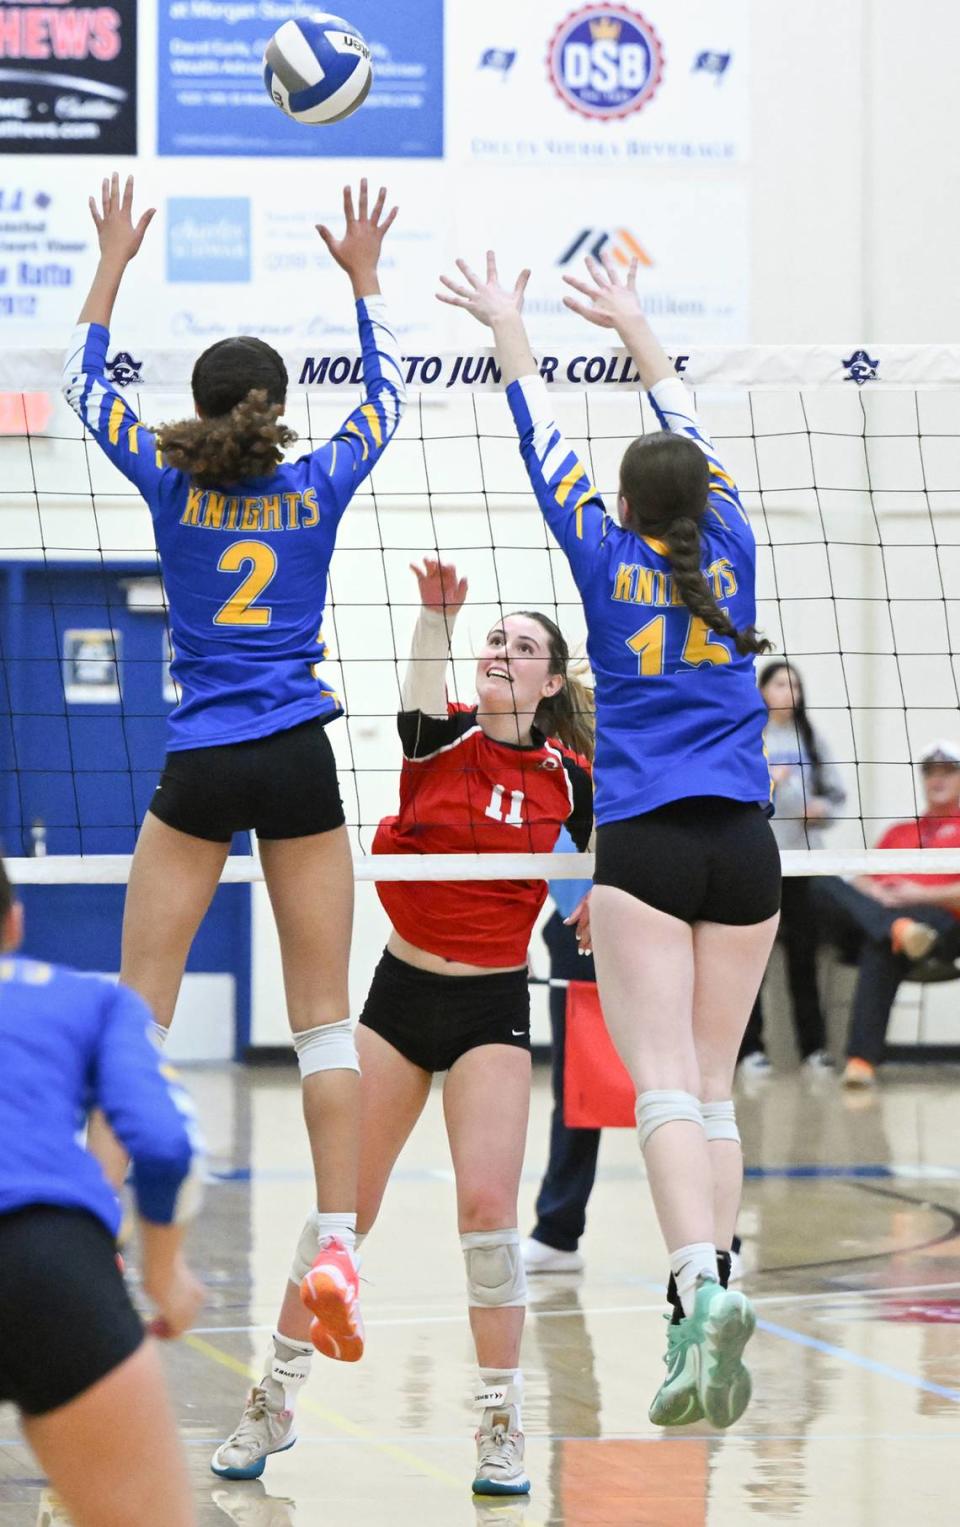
[594,796,780,927]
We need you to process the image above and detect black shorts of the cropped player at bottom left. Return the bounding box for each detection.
[0,1205,143,1417]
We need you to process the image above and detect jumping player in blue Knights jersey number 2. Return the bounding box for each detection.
[64,176,403,1358]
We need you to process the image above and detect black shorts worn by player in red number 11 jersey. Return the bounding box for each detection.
[360,950,530,1072]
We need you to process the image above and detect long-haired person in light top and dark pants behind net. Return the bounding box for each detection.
[740,660,847,1077]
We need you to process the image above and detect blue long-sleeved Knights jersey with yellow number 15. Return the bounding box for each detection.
[507,368,771,823]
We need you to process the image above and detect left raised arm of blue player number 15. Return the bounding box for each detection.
[438,250,609,585]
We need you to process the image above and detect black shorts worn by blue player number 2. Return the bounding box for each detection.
[150,721,345,843]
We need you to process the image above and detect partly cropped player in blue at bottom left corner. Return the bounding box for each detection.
[0,861,203,1527]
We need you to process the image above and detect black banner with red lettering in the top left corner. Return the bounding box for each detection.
[0,0,137,154]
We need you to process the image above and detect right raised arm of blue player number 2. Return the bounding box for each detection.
[311,180,406,515]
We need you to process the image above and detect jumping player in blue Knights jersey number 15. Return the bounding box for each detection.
[441,255,780,1426]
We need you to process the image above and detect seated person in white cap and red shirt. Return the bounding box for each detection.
[815,741,960,1087]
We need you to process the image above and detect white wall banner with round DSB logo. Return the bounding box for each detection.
[449,0,749,168]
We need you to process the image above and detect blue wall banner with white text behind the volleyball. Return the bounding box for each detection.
[157,0,444,159]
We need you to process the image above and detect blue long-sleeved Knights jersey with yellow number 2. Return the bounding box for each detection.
[63,298,404,750]
